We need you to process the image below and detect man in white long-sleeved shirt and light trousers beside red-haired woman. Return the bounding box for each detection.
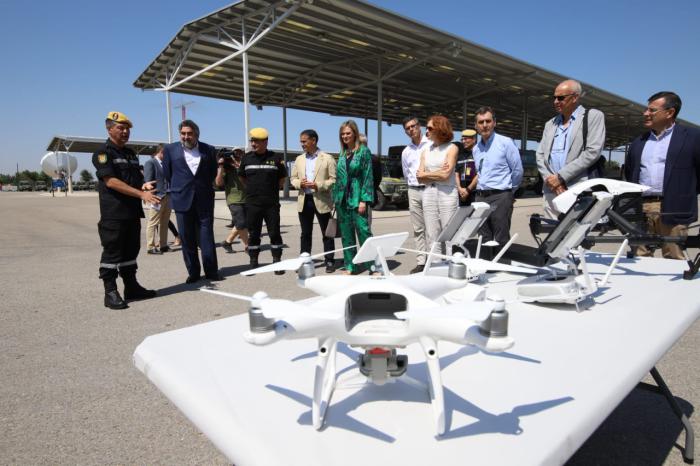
[401,116,430,273]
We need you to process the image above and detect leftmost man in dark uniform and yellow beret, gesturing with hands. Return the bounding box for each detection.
[92,112,160,309]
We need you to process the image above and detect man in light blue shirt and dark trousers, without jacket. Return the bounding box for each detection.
[473,107,523,246]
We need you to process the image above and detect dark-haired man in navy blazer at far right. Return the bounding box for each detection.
[625,92,700,259]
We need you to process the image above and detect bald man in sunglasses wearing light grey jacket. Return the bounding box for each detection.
[537,79,605,219]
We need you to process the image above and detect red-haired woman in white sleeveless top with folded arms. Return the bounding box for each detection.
[416,115,459,254]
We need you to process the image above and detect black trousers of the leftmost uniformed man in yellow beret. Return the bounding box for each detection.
[97,218,141,280]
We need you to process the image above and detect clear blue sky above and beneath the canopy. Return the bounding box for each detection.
[0,0,700,173]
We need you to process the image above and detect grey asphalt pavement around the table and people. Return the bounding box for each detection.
[0,192,700,465]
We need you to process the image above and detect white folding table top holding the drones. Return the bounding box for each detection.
[134,254,700,466]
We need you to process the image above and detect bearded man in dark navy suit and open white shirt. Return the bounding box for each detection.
[163,120,223,283]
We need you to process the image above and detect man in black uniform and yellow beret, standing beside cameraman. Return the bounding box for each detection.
[239,128,287,275]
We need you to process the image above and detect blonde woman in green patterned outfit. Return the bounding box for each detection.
[333,120,374,275]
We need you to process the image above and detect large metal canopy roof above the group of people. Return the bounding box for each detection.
[134,0,695,153]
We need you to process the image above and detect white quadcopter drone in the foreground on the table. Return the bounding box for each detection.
[203,233,514,435]
